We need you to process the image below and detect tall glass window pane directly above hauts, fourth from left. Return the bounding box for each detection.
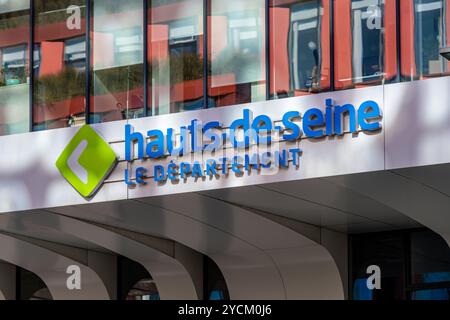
[147,0,204,115]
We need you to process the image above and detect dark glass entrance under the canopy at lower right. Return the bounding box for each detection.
[350,229,450,300]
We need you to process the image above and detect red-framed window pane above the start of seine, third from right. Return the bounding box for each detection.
[269,0,330,99]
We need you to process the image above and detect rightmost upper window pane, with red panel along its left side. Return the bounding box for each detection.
[400,0,450,80]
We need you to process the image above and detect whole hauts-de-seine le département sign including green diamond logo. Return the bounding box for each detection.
[56,99,382,199]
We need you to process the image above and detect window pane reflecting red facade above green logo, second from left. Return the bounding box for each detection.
[33,0,86,130]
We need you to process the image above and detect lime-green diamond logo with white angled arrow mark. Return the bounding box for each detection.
[56,125,117,199]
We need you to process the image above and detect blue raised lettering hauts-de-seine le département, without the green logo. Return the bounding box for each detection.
[124,99,381,186]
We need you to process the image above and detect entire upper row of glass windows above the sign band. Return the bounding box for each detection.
[0,0,450,135]
